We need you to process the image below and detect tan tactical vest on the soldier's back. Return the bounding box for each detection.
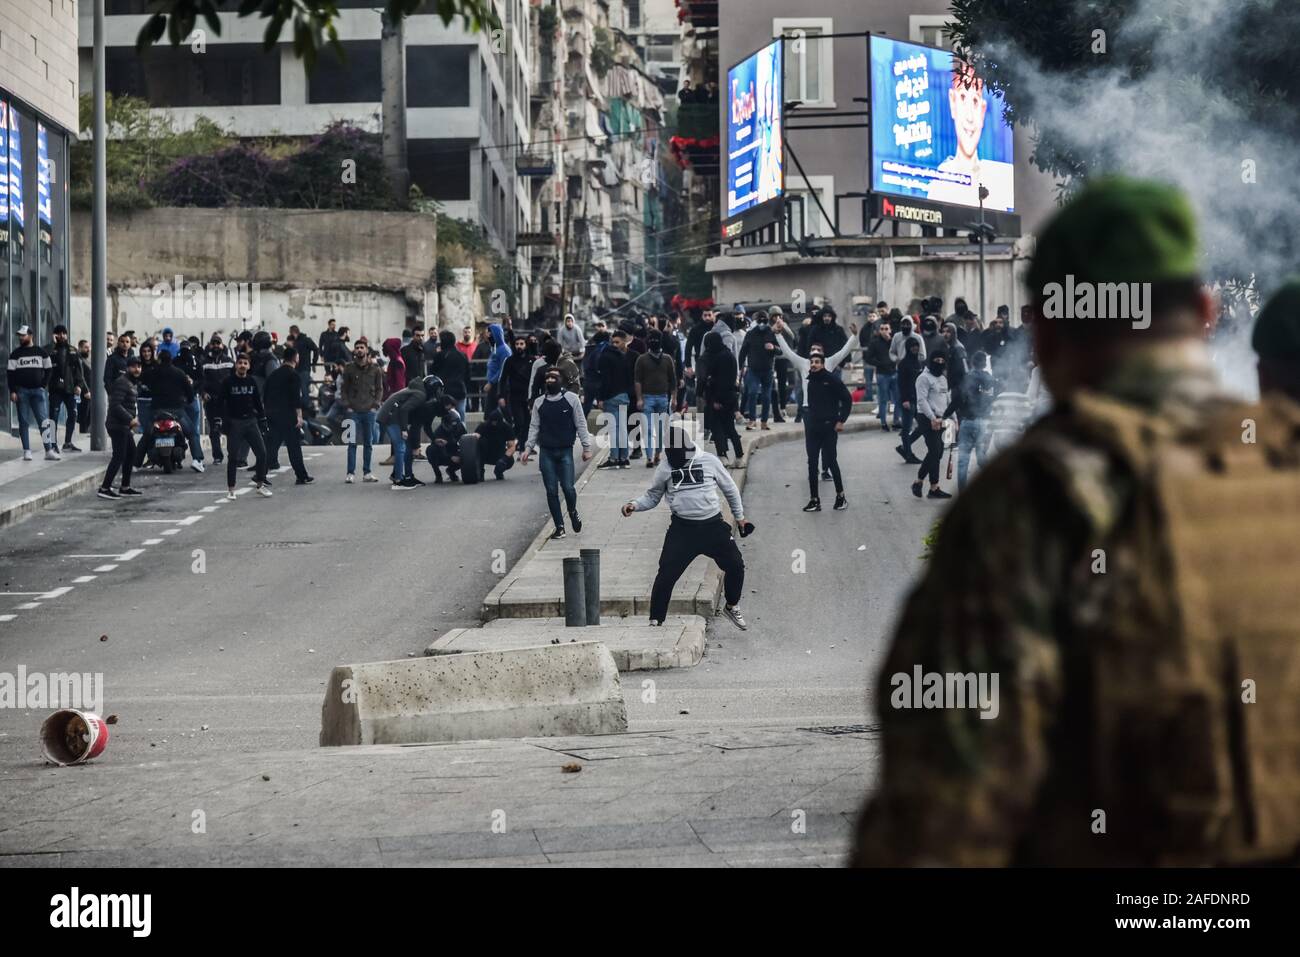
[1027,394,1300,866]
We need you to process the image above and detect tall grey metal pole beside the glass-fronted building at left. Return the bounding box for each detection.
[90,0,108,452]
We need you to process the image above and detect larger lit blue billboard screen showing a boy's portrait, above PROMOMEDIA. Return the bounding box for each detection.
[871,36,1015,212]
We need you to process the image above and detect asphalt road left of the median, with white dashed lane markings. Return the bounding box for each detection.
[0,447,579,767]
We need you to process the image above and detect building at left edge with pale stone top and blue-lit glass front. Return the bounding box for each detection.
[0,0,79,428]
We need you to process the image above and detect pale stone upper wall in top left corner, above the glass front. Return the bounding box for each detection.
[0,0,77,133]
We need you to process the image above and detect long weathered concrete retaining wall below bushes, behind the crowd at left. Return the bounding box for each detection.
[72,208,438,341]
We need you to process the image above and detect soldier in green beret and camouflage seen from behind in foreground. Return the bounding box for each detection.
[852,179,1300,866]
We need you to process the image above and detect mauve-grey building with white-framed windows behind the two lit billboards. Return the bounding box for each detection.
[707,0,1053,321]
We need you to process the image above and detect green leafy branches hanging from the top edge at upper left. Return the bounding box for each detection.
[135,0,501,70]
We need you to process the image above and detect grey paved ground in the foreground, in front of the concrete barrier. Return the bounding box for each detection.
[0,726,879,867]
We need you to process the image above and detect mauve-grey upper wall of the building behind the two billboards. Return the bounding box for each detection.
[718,0,1054,234]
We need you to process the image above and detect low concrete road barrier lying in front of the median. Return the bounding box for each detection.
[320,641,628,748]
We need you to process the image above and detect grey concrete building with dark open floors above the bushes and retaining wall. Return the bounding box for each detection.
[79,0,540,313]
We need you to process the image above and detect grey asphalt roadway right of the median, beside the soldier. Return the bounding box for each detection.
[624,430,956,729]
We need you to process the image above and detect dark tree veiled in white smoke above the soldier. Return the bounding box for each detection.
[950,0,1300,287]
